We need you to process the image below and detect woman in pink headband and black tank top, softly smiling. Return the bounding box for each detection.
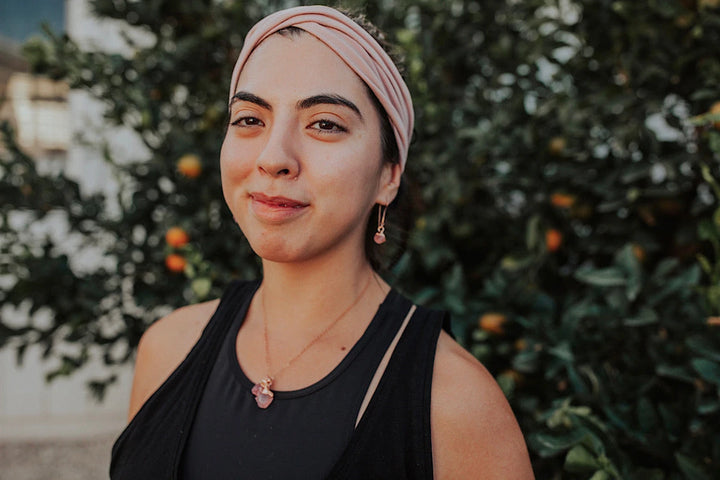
[111,6,532,480]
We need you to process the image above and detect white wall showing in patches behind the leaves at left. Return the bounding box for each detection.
[0,0,153,441]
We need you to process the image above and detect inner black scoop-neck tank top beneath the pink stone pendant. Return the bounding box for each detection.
[180,280,410,480]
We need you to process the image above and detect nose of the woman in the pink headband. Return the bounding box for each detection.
[256,122,300,178]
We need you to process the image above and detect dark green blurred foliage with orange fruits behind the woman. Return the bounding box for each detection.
[0,0,720,480]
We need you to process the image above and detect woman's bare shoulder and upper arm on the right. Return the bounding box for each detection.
[431,332,533,480]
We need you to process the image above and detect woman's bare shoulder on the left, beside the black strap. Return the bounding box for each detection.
[128,300,220,419]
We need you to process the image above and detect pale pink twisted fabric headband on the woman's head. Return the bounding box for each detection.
[230,5,414,169]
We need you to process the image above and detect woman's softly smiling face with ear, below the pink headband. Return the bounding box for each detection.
[220,33,400,262]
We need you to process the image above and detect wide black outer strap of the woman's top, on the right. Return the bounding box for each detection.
[327,307,449,480]
